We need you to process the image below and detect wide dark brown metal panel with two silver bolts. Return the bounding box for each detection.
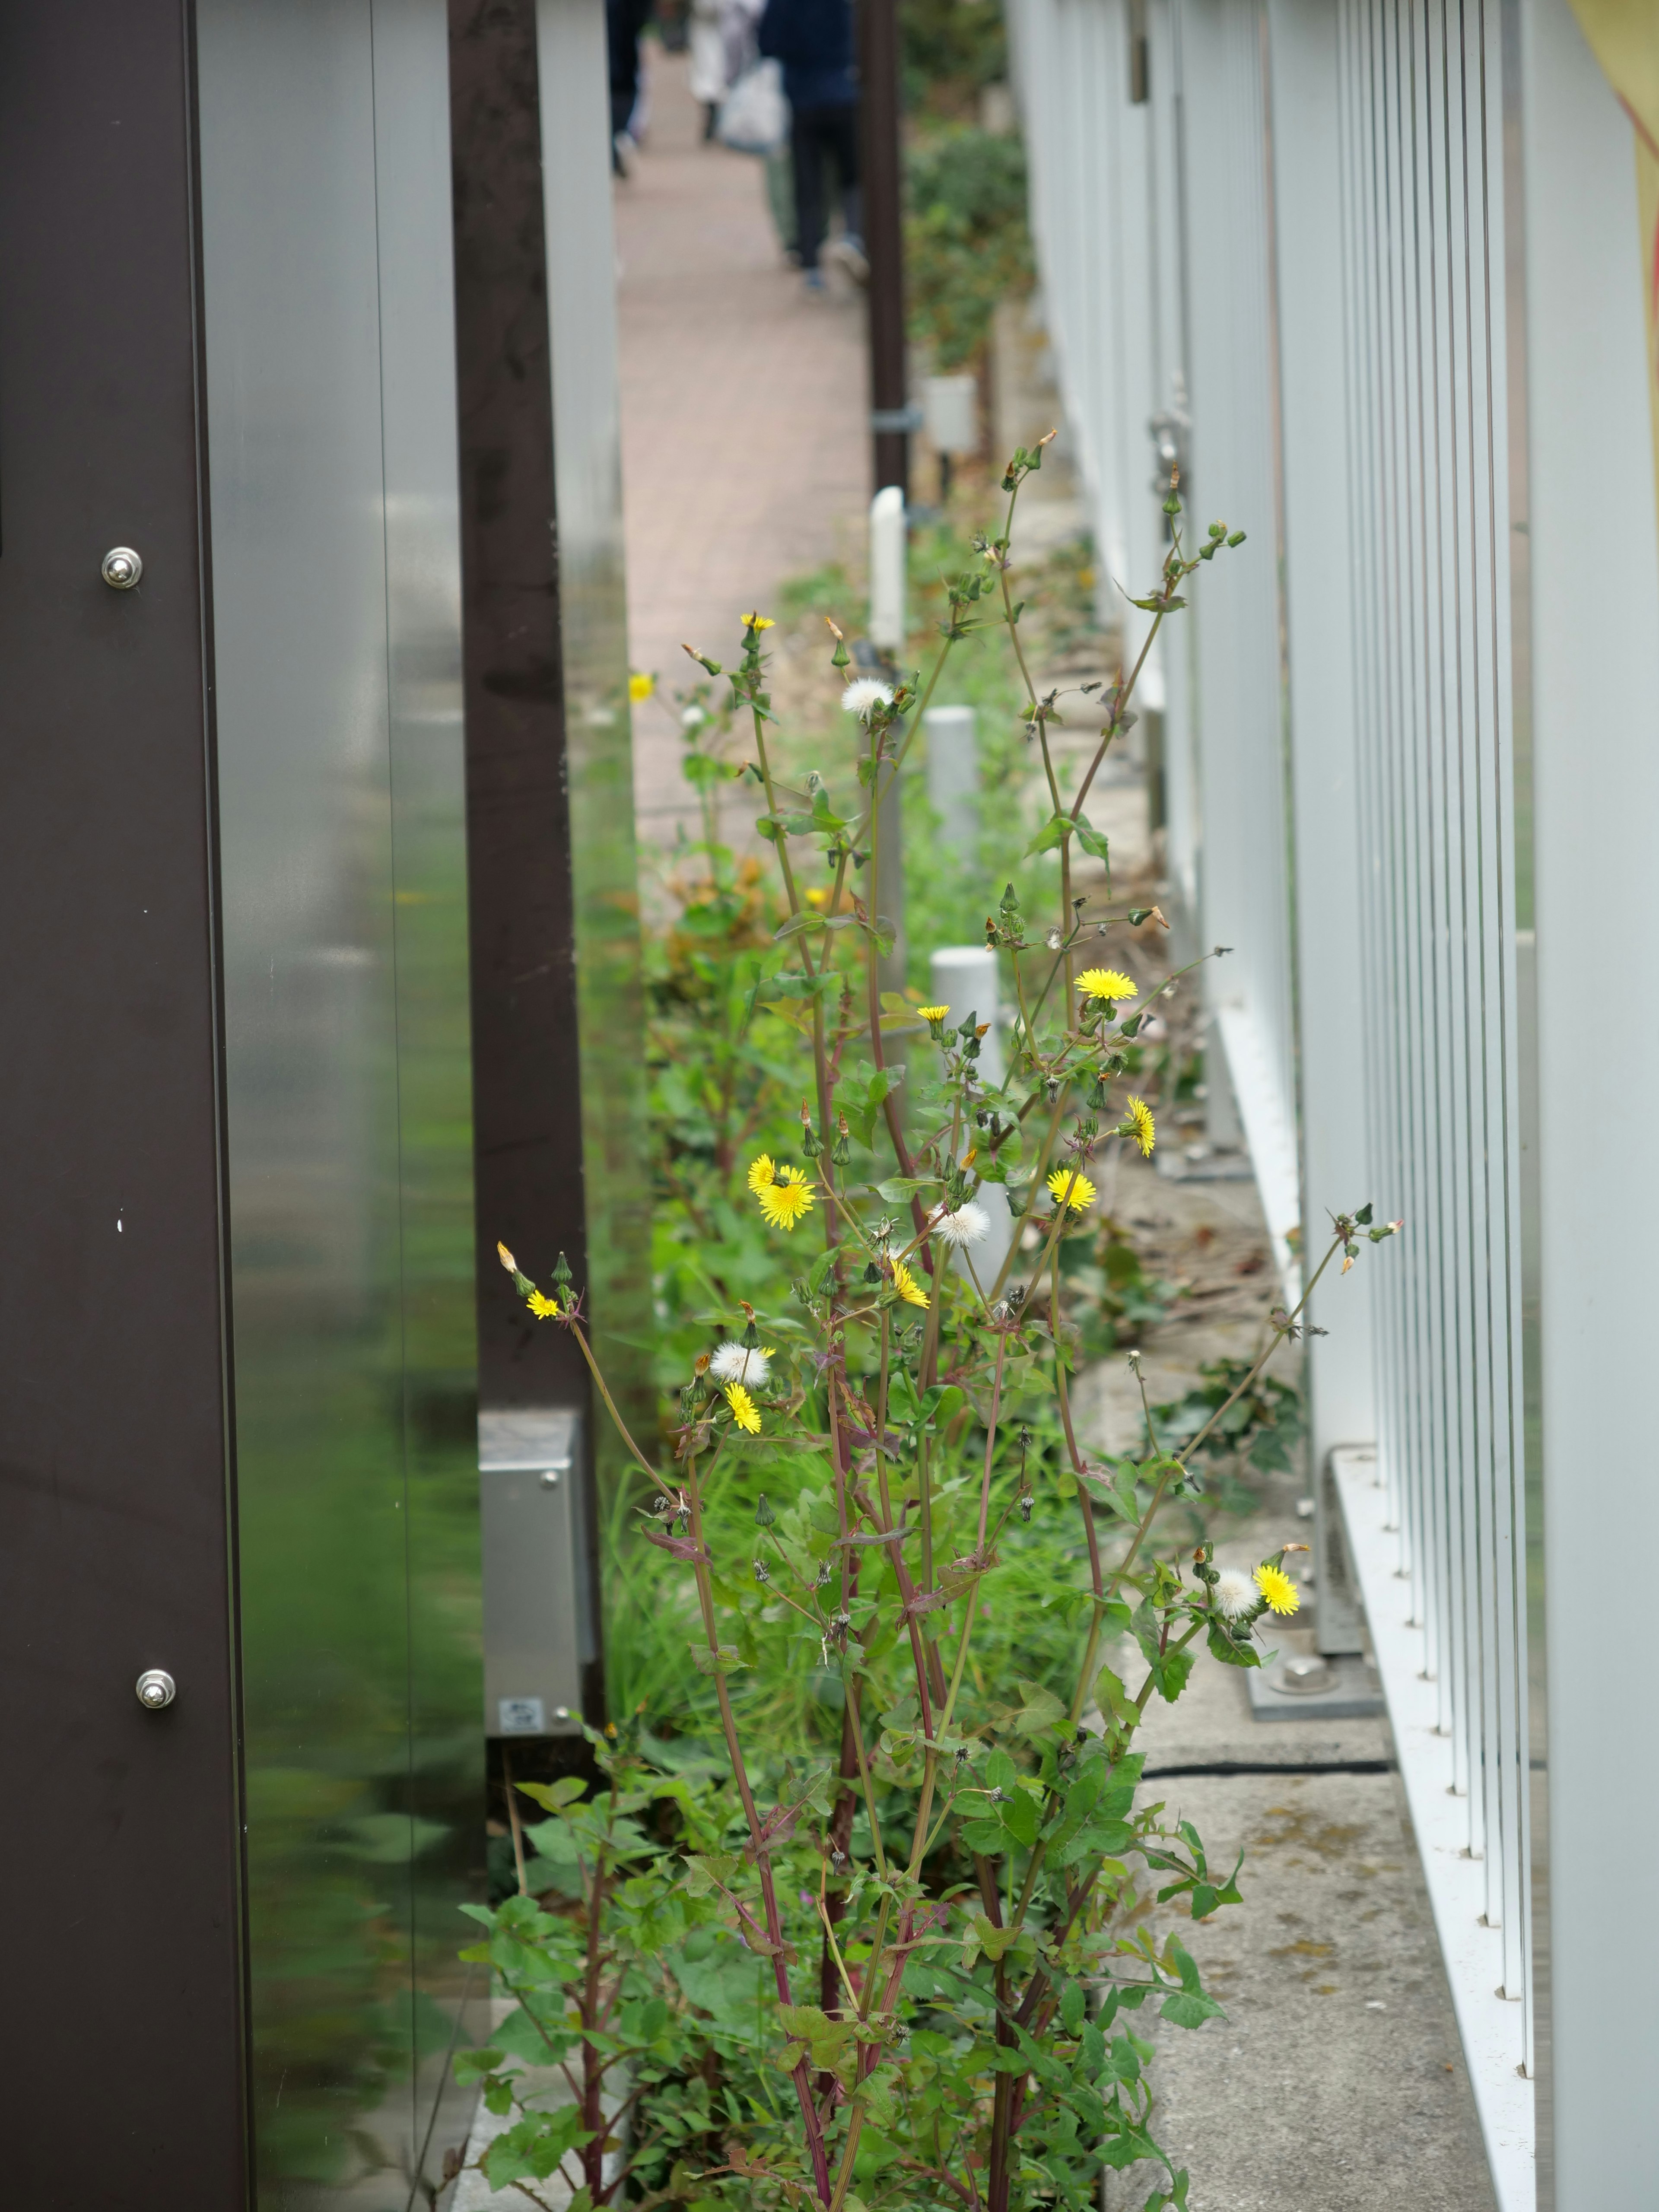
[0,0,245,2212]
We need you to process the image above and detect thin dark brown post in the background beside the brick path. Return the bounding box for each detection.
[858,0,911,500]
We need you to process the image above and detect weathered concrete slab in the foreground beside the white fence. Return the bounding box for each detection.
[1106,1761,1493,2212]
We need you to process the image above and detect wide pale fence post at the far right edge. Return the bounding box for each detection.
[1506,0,1659,2185]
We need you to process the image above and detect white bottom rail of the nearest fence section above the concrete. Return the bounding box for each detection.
[1332,1449,1537,2212]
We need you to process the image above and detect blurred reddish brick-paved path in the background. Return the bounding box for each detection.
[615,42,869,836]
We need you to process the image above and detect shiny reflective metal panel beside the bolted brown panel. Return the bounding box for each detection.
[199,0,482,2212]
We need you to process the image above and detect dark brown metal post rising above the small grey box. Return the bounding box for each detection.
[449,0,588,1407]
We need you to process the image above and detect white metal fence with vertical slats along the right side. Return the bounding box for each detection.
[1013,0,1659,2212]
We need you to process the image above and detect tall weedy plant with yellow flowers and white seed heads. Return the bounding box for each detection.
[462,440,1398,2212]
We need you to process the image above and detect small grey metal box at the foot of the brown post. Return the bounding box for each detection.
[478,1407,593,1736]
